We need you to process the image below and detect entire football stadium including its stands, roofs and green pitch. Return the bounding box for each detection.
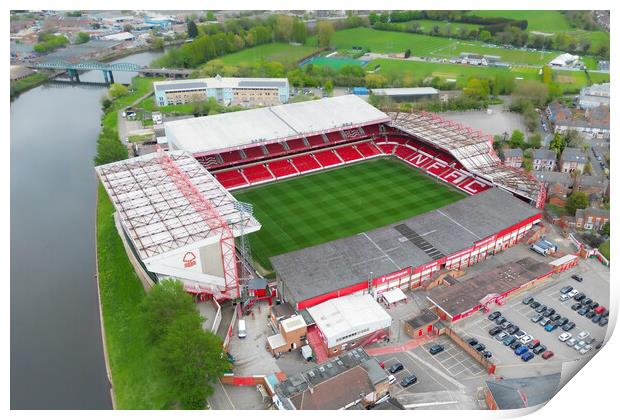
[97,95,545,310]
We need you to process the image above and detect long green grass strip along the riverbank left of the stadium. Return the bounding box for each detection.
[97,184,168,409]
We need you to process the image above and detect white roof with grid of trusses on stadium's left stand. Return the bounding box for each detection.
[95,151,260,261]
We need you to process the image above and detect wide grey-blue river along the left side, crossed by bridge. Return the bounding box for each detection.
[10,52,161,409]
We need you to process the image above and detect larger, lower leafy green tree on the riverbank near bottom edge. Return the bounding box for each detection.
[155,314,230,409]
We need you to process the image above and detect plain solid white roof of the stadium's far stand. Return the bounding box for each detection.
[164,95,389,154]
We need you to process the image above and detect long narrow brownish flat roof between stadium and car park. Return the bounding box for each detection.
[427,257,551,316]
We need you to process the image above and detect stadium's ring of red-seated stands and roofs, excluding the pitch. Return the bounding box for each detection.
[97,95,545,309]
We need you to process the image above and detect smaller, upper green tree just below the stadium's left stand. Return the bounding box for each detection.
[141,279,196,343]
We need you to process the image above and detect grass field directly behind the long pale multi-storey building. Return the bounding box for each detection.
[217,42,317,66]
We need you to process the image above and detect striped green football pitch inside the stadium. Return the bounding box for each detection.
[233,158,465,271]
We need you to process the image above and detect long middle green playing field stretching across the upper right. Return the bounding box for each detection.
[307,28,560,65]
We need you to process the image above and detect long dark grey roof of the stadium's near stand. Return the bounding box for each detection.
[270,188,540,302]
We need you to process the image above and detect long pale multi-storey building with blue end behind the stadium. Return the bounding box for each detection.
[153,75,289,106]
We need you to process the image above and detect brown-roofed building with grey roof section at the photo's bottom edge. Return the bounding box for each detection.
[273,349,389,410]
